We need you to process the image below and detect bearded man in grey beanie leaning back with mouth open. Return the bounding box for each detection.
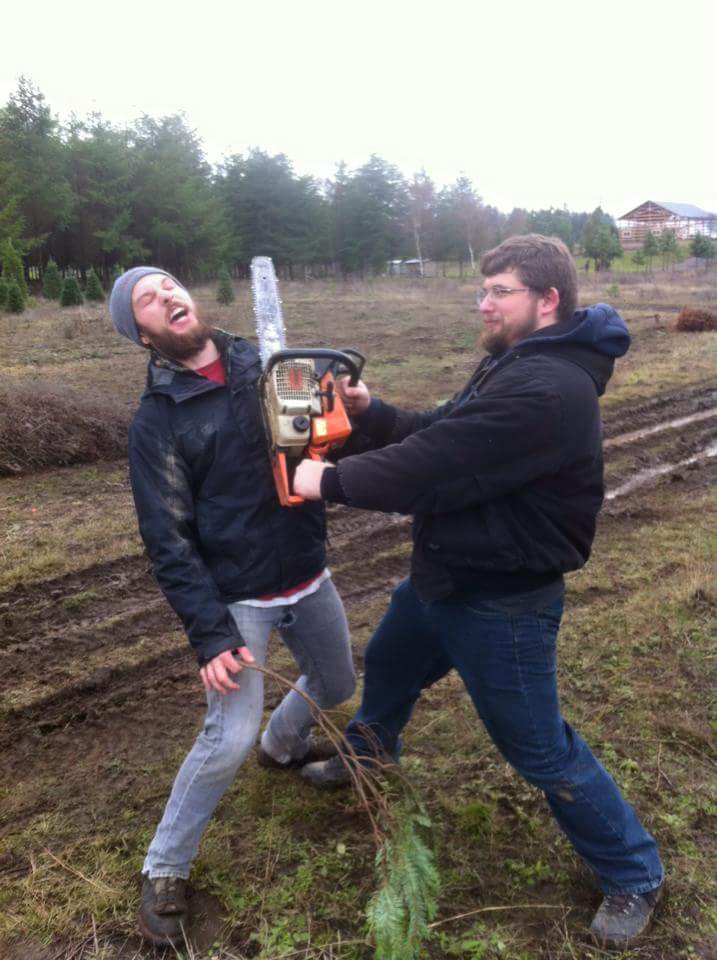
[110,267,355,945]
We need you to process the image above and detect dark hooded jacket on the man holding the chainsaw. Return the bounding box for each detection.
[321,304,630,600]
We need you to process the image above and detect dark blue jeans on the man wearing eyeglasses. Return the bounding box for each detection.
[347,581,663,894]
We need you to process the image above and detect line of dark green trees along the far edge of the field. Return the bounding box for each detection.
[0,78,622,285]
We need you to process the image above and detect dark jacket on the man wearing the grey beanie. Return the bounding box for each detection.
[129,331,326,664]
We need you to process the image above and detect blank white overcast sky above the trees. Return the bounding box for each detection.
[0,0,717,216]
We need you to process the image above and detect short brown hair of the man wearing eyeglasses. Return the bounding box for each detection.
[480,233,578,323]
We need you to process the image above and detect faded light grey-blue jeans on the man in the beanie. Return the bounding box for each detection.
[142,579,356,879]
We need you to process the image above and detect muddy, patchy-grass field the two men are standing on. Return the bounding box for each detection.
[0,275,717,960]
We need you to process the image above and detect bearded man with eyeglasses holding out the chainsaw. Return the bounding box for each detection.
[295,234,664,947]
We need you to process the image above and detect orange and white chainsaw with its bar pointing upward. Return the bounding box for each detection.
[251,257,365,507]
